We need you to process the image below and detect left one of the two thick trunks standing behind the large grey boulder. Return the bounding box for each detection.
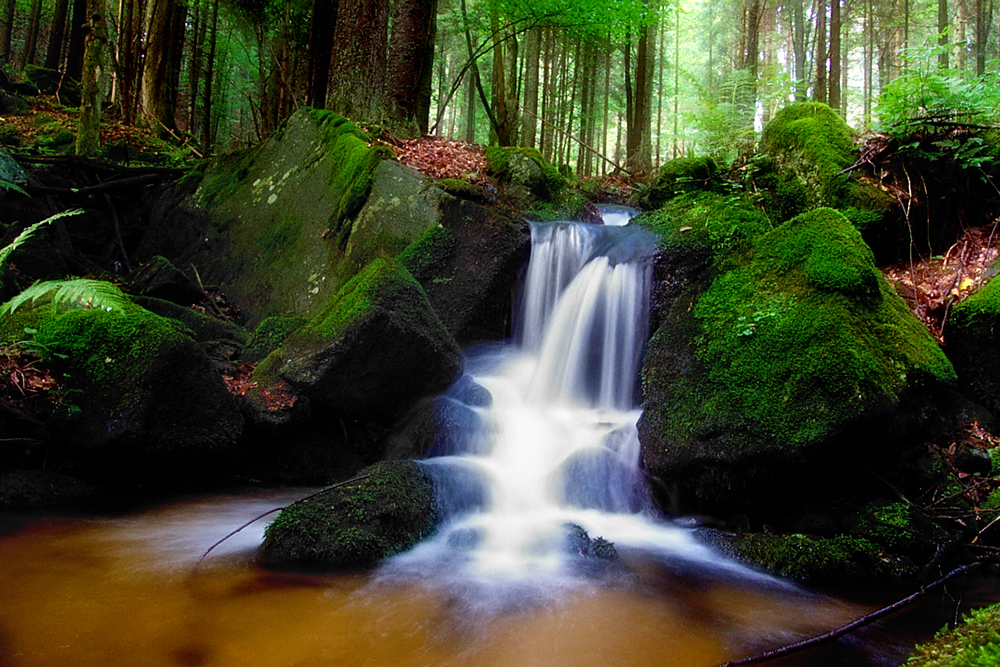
[329,0,389,123]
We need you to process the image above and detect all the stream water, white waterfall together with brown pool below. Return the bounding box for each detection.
[0,206,968,667]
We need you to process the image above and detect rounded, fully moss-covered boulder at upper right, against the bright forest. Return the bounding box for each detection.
[752,102,894,234]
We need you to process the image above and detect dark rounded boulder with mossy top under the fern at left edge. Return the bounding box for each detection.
[3,284,243,472]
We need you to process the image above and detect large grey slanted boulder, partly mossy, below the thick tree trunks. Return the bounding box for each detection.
[146,109,445,326]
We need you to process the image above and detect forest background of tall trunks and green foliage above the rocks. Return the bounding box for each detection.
[0,0,1000,177]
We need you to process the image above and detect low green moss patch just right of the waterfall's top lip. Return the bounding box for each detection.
[632,192,771,256]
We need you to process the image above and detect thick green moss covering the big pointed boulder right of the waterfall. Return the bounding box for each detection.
[644,209,955,456]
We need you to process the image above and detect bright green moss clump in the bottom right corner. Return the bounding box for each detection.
[904,604,1000,667]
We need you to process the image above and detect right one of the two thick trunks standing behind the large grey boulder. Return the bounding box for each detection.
[387,0,437,135]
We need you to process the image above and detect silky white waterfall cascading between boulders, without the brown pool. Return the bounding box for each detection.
[385,211,764,607]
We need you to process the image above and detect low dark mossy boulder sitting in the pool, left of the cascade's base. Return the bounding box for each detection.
[262,460,436,569]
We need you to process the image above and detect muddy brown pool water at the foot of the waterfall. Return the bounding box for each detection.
[0,490,993,667]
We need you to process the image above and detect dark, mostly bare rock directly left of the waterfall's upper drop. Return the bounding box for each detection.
[399,198,531,345]
